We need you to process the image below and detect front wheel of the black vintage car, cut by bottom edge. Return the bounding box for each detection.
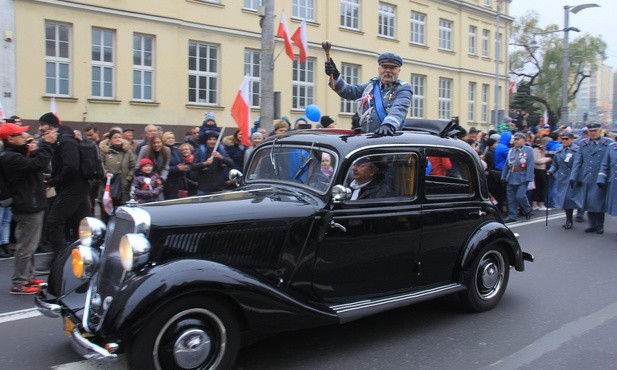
[127,296,240,370]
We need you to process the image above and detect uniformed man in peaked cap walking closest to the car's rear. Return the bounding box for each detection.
[501,132,535,222]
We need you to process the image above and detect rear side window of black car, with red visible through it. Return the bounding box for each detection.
[424,151,474,199]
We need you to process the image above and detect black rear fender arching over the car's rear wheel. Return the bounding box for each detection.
[460,222,525,271]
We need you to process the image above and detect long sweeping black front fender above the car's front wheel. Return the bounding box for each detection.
[101,259,339,337]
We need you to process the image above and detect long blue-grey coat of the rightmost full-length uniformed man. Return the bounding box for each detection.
[570,136,613,212]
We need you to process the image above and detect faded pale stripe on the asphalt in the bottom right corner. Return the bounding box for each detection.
[480,302,617,370]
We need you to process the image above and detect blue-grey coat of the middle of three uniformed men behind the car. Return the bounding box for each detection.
[548,144,582,209]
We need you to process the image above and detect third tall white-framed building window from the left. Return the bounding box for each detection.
[133,34,154,101]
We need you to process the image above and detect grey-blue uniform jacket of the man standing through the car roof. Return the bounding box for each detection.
[334,77,413,132]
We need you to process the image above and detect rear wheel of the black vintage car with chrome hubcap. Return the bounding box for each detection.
[460,245,510,312]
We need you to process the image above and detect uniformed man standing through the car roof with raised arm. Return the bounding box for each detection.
[325,52,413,136]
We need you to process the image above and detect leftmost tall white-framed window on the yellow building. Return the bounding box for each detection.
[45,22,71,96]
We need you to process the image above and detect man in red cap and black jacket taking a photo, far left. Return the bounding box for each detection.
[0,123,58,294]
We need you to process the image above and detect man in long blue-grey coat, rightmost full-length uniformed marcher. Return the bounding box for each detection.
[570,123,613,234]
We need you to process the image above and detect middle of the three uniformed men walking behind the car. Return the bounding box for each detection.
[548,132,581,230]
